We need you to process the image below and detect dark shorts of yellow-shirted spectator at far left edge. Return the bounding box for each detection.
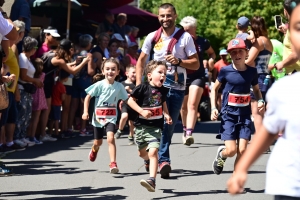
[0,92,18,126]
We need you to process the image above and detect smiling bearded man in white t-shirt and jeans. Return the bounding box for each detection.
[136,3,200,178]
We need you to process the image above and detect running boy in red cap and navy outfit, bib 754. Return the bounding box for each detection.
[211,38,265,175]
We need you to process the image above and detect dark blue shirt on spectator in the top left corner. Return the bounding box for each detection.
[10,0,31,32]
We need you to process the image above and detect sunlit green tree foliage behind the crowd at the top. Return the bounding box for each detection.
[140,0,283,56]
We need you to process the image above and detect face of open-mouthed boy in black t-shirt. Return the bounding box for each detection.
[148,65,167,87]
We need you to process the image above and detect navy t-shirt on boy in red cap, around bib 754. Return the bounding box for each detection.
[217,65,258,115]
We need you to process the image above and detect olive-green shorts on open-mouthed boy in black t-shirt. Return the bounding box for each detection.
[134,126,161,151]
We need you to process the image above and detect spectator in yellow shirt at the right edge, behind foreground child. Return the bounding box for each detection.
[272,0,300,74]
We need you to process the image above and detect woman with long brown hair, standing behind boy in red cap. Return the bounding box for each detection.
[246,16,273,130]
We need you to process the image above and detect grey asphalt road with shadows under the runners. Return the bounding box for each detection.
[0,122,273,200]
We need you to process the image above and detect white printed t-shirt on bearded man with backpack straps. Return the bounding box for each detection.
[142,28,197,90]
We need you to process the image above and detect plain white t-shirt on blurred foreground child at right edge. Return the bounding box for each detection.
[263,72,300,197]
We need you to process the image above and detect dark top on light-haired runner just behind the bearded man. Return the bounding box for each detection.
[186,36,210,83]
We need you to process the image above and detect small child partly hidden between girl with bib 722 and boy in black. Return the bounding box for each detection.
[115,65,136,145]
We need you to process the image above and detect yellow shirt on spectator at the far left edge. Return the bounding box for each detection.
[4,48,20,93]
